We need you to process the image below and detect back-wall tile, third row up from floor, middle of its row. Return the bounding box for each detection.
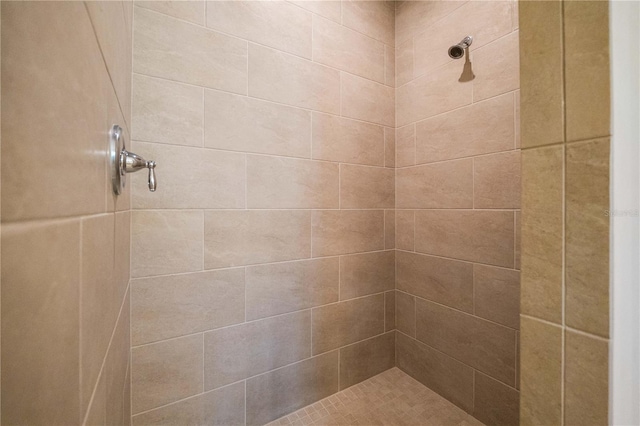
[246,257,339,320]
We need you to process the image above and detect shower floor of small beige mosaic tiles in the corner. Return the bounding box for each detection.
[267,368,483,426]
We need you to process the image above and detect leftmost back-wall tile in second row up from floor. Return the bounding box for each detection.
[131,334,203,414]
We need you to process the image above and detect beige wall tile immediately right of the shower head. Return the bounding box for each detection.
[473,31,520,101]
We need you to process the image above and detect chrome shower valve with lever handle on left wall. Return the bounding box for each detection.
[109,124,156,195]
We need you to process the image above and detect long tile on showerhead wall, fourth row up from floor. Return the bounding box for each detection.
[416,210,514,267]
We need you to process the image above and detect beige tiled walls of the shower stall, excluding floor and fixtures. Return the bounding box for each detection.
[0,0,609,425]
